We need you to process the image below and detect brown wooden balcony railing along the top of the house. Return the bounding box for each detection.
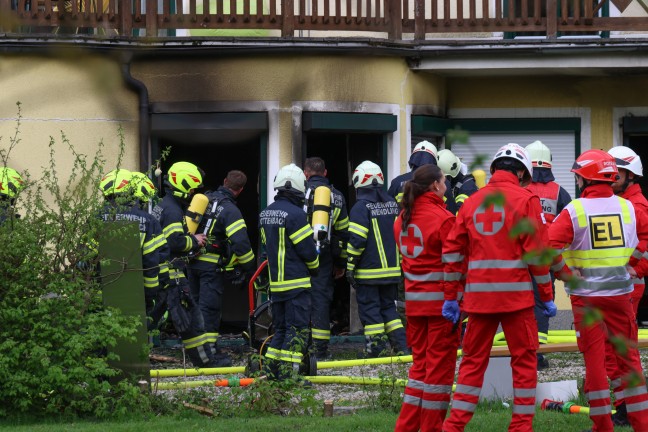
[0,0,648,40]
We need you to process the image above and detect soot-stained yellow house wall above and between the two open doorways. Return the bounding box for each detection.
[132,55,445,168]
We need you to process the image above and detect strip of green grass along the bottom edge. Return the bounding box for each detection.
[0,403,631,432]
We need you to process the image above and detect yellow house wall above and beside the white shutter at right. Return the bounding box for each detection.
[447,75,648,150]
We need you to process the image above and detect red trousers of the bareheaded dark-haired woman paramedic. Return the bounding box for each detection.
[395,316,461,432]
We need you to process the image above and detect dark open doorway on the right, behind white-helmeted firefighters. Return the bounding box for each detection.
[303,132,386,335]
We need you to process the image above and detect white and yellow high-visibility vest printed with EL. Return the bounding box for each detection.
[563,196,639,297]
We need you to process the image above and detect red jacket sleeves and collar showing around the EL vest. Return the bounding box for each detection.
[549,184,648,267]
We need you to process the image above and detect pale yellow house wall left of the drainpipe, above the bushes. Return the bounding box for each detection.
[0,53,139,178]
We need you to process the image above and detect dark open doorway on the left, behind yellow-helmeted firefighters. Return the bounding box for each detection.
[151,109,268,334]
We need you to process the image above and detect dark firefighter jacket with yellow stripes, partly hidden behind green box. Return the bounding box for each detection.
[101,204,166,290]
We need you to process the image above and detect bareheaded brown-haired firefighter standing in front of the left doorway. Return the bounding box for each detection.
[188,170,256,367]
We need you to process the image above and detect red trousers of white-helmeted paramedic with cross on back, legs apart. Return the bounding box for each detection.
[443,307,539,432]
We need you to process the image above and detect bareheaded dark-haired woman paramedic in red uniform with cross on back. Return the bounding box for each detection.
[394,164,461,432]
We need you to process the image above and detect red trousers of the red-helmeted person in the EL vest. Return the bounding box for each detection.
[571,294,648,432]
